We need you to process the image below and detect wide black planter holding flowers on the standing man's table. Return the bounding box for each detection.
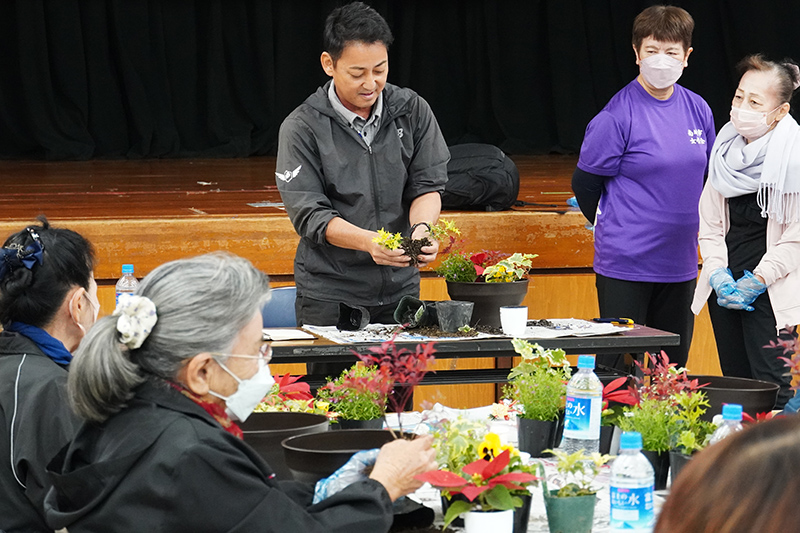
[447,279,528,328]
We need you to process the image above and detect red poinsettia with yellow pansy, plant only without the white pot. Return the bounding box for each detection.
[416,433,539,527]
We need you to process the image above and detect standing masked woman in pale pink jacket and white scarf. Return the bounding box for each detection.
[692,55,800,407]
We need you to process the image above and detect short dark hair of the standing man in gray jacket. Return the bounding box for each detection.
[322,2,394,63]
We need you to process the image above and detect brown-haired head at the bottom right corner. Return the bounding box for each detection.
[654,416,800,533]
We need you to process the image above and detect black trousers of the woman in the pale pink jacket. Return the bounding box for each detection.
[708,292,794,409]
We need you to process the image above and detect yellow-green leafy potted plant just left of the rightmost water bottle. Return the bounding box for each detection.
[669,390,716,482]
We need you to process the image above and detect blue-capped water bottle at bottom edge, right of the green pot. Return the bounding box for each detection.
[610,431,655,533]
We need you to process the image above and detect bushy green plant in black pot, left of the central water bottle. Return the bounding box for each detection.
[503,339,571,457]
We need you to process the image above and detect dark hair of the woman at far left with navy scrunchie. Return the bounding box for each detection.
[0,216,95,328]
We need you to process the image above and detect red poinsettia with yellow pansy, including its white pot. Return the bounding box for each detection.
[417,433,538,533]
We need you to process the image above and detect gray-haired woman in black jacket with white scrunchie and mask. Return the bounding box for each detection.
[45,253,436,533]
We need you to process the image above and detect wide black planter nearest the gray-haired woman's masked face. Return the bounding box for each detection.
[240,412,330,480]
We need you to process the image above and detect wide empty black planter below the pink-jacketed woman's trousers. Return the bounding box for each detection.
[689,375,780,422]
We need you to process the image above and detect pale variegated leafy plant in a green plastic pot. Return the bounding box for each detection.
[540,450,611,533]
